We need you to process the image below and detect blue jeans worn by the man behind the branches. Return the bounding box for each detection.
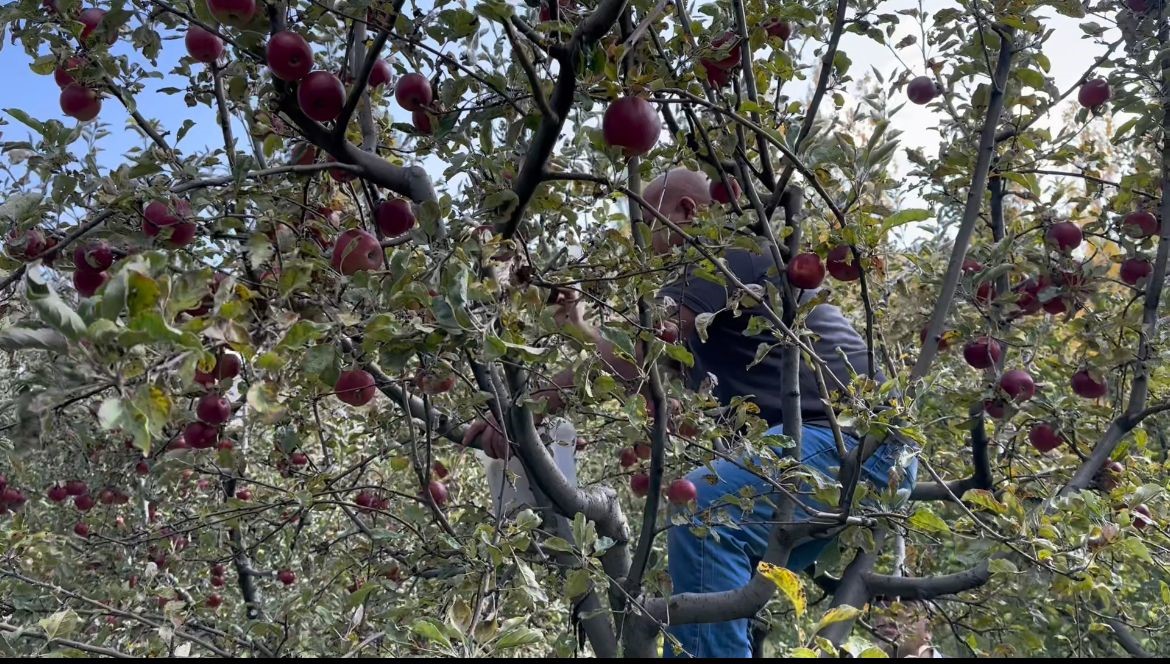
[662,426,918,658]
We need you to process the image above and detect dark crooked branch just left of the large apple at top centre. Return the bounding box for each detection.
[497,0,626,238]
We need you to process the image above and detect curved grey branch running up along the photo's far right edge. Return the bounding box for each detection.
[1060,14,1170,496]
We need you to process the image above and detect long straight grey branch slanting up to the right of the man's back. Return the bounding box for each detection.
[909,29,1014,385]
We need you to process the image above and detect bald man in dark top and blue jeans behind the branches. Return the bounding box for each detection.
[464,168,916,657]
